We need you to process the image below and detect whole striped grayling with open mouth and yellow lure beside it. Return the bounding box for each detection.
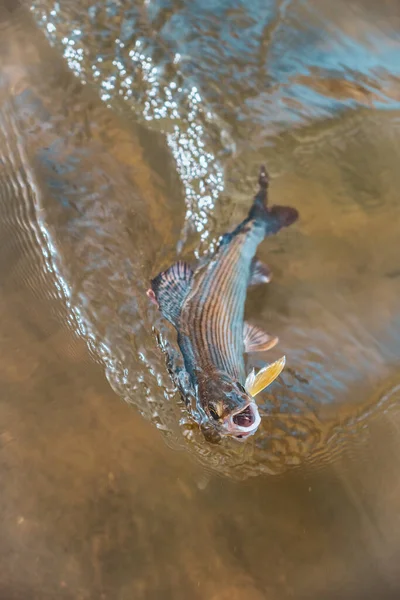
[147,167,298,438]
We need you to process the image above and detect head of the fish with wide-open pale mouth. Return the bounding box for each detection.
[201,374,261,440]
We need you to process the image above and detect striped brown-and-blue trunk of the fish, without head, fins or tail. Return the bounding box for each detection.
[178,220,264,385]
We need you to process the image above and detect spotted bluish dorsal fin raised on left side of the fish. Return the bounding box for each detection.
[151,261,193,326]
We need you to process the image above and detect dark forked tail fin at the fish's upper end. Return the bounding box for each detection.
[249,166,299,236]
